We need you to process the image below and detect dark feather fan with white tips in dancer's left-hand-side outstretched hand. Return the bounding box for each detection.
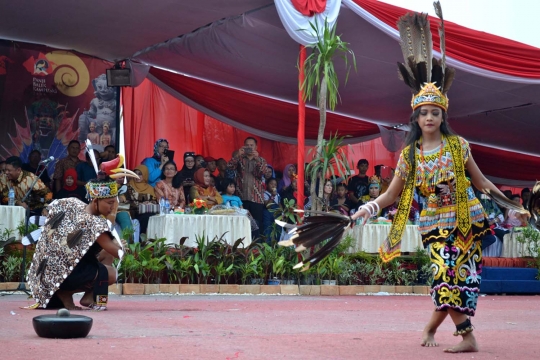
[278,211,352,271]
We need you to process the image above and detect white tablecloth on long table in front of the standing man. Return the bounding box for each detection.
[146,215,251,247]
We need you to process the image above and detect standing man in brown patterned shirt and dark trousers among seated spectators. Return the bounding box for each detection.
[227,137,266,232]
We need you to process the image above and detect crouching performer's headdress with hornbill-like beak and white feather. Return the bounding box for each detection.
[86,140,139,199]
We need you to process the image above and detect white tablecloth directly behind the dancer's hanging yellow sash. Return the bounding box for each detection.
[345,224,423,253]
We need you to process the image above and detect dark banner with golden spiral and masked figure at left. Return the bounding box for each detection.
[0,40,118,174]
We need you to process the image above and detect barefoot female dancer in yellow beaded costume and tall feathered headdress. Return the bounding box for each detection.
[352,8,525,352]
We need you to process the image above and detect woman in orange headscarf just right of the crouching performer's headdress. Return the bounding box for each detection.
[126,165,159,234]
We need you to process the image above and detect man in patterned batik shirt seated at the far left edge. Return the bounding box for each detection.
[0,156,52,216]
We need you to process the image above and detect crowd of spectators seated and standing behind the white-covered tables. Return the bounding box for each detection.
[0,137,530,245]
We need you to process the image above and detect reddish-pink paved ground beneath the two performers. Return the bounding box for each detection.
[0,295,540,360]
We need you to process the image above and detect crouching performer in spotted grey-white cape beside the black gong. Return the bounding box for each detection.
[27,149,136,310]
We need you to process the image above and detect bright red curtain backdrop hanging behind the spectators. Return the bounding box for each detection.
[122,80,397,173]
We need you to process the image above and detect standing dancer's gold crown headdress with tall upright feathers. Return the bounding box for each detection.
[397,1,455,111]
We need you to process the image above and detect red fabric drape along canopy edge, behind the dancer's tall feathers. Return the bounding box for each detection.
[353,0,540,79]
